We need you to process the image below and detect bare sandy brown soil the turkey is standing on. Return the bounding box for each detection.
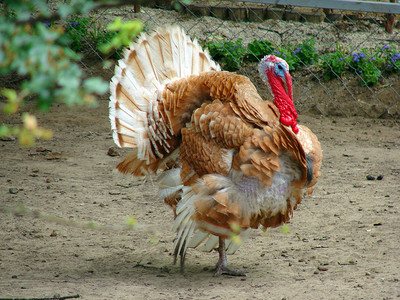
[0,5,400,299]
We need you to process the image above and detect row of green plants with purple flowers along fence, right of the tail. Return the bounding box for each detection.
[206,39,400,86]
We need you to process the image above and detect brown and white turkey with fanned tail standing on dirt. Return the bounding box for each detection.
[109,26,322,275]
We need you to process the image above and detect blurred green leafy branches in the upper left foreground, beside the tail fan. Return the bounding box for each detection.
[0,0,141,145]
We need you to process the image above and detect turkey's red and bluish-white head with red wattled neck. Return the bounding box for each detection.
[258,55,299,133]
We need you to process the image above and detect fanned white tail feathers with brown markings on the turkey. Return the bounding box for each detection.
[109,26,220,175]
